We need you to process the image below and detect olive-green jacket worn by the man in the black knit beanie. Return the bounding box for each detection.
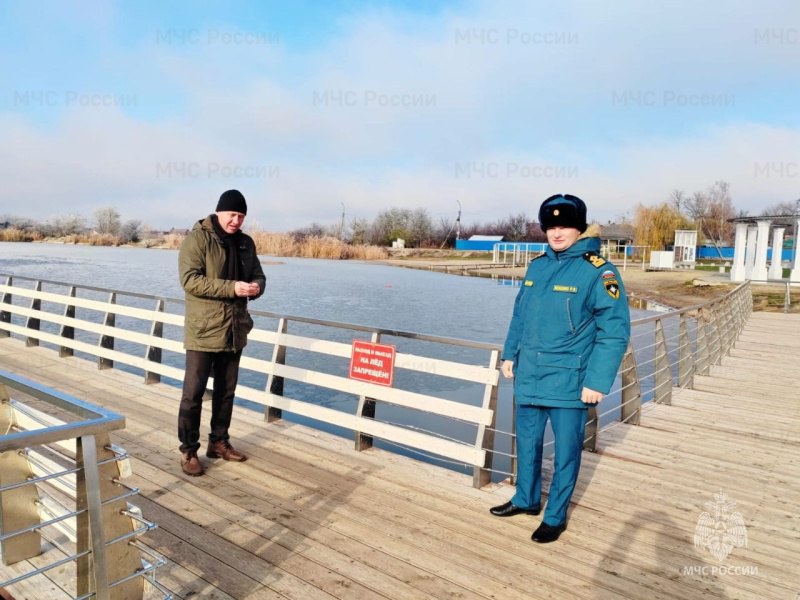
[178,215,267,352]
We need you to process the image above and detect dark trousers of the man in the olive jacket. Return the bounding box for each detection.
[178,350,242,452]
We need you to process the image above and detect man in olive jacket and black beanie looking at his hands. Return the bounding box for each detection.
[178,190,267,476]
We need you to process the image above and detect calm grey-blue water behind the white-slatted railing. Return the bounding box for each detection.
[0,242,649,478]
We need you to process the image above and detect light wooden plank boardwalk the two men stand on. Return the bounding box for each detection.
[0,313,800,600]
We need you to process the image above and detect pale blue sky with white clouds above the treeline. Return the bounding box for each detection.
[0,0,800,231]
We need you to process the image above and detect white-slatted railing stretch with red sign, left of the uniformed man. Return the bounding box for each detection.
[0,276,499,486]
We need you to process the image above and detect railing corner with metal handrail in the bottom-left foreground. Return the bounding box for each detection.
[0,371,170,600]
